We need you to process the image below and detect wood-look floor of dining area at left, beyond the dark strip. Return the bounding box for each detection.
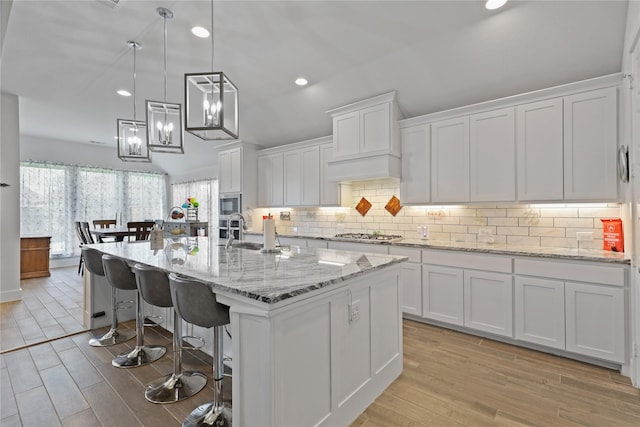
[0,267,85,352]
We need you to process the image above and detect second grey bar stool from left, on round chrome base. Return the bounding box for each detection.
[102,254,167,368]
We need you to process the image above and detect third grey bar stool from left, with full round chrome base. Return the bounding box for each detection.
[133,264,207,403]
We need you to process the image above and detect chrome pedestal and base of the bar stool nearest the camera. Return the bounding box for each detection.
[182,326,231,427]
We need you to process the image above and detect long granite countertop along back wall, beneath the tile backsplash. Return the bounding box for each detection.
[246,231,631,264]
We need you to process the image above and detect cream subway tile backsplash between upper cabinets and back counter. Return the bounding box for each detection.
[252,180,622,249]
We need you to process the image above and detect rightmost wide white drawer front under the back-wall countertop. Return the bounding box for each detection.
[514,259,625,286]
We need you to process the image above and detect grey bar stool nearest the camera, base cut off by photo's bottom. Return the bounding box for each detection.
[169,273,231,427]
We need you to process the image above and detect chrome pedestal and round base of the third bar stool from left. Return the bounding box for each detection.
[144,310,207,403]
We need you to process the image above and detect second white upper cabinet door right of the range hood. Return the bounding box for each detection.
[431,117,469,203]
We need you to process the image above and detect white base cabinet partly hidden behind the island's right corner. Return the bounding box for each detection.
[389,246,422,316]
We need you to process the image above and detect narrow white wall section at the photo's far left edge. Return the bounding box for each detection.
[0,93,22,302]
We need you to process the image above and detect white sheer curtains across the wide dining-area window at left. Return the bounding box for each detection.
[20,162,166,257]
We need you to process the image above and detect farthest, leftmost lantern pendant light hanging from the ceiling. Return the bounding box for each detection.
[117,41,151,162]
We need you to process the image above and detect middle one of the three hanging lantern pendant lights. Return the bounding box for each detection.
[145,7,184,154]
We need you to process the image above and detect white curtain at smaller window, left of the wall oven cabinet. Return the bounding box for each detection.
[171,179,218,235]
